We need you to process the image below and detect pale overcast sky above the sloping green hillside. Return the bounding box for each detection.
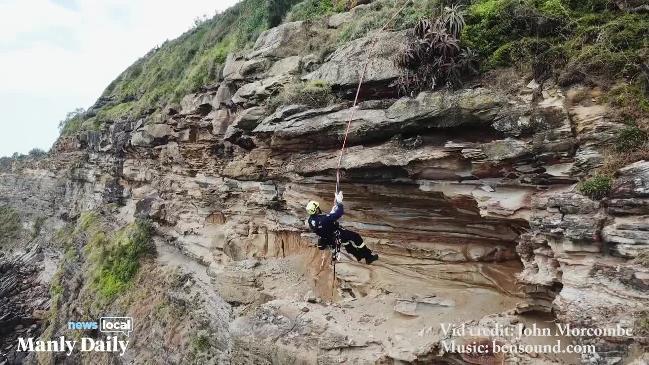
[0,0,237,156]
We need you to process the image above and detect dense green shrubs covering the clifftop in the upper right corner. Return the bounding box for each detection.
[464,0,649,84]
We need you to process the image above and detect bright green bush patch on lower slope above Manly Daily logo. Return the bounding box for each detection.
[85,219,151,301]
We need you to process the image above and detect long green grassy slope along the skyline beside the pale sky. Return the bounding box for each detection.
[60,0,298,135]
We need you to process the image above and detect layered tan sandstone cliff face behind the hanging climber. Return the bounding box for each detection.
[0,7,649,364]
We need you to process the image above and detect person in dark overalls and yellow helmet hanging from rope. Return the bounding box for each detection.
[306,191,379,264]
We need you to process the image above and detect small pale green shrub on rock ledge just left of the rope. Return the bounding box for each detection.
[267,80,338,110]
